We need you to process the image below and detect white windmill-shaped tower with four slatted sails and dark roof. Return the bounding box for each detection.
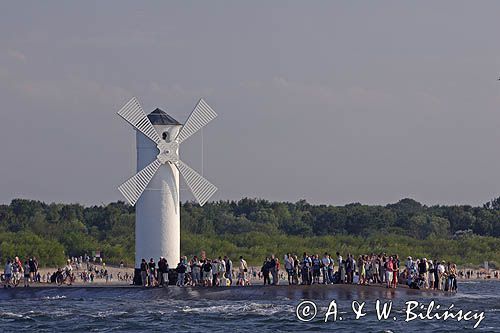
[118,97,217,280]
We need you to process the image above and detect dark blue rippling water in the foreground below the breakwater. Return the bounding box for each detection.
[0,281,500,333]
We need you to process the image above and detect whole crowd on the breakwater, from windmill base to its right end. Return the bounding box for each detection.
[136,252,480,291]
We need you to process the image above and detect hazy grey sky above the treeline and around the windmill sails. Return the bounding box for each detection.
[0,1,500,205]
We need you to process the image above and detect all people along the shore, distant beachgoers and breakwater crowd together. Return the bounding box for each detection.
[1,252,500,292]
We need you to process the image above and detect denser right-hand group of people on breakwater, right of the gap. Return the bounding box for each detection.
[261,252,458,291]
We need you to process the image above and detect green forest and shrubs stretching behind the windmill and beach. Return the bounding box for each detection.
[0,198,500,267]
